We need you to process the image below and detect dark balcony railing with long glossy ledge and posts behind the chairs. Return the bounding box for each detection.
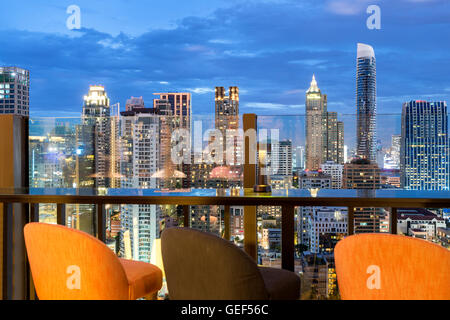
[0,188,450,299]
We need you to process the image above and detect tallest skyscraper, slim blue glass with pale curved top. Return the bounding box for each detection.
[356,43,377,161]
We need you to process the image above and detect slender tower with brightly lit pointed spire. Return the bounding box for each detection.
[306,75,327,170]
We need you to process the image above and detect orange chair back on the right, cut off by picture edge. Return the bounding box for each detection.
[334,234,450,300]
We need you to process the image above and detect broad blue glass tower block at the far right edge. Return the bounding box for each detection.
[400,101,450,190]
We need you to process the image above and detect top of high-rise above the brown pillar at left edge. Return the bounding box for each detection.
[0,67,30,116]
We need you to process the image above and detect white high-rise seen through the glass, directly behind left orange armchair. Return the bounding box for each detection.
[120,108,160,262]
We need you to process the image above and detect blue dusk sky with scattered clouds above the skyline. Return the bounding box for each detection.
[0,0,450,122]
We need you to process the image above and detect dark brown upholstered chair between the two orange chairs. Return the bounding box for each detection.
[161,228,300,300]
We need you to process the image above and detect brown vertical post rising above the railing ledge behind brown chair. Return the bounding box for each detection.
[242,113,258,260]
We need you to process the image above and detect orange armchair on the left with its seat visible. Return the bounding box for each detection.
[24,223,162,300]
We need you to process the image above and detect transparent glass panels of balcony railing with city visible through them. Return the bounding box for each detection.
[29,113,450,299]
